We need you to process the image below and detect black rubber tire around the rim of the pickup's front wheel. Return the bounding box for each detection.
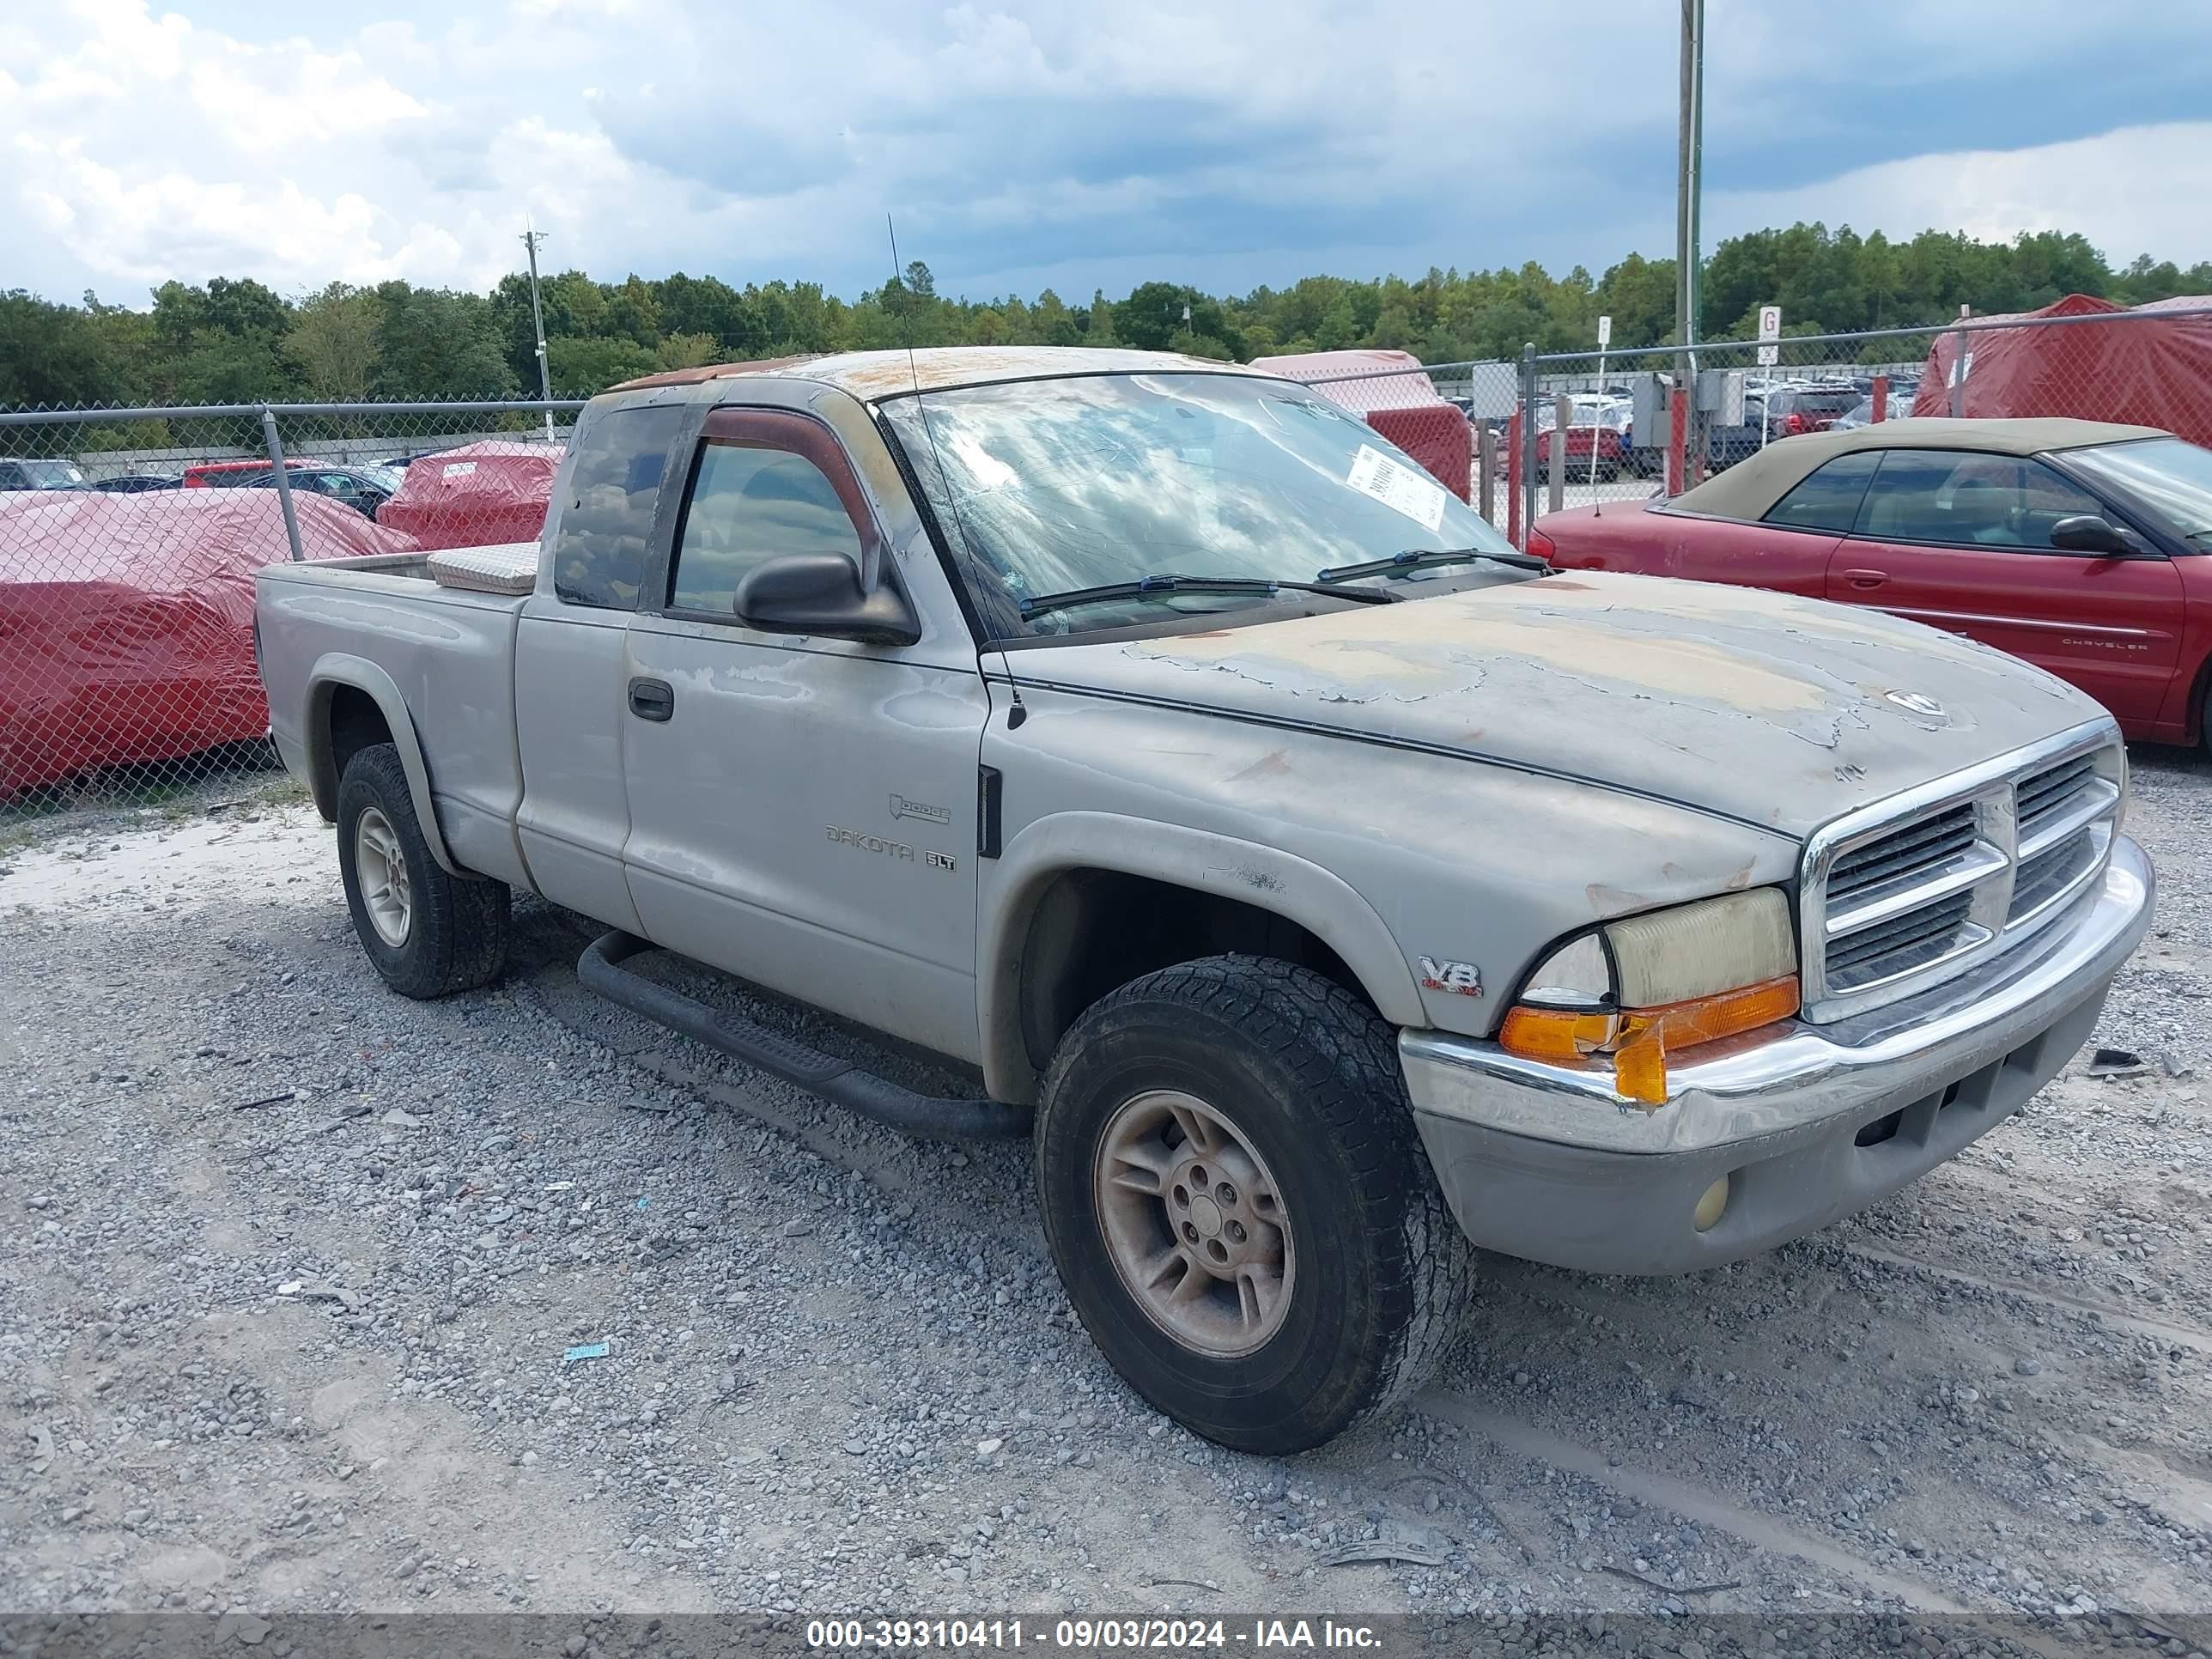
[1036,956,1474,1455]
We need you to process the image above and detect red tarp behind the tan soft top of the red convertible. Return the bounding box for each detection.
[1913,295,2212,445]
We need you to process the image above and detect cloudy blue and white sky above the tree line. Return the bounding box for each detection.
[0,0,2212,303]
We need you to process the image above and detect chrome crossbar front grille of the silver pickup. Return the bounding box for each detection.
[1801,723,2126,1022]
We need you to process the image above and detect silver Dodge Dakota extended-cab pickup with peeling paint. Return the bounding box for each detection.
[257,349,2152,1451]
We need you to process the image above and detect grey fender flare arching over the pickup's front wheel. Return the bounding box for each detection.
[975,811,1429,1102]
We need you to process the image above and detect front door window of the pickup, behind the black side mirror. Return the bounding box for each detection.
[668,438,860,619]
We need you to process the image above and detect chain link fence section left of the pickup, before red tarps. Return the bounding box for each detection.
[0,400,581,827]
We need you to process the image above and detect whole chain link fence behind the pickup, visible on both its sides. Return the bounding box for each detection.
[0,299,2212,817]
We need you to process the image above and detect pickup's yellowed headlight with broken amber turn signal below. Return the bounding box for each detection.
[1498,887,1798,1106]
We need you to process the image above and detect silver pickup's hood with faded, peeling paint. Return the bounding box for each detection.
[1006,571,2106,836]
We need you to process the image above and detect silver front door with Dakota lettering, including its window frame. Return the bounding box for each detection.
[622,410,988,1057]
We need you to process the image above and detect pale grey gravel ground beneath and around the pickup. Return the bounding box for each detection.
[0,750,2212,1655]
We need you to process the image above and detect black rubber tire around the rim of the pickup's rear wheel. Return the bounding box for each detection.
[338,744,514,998]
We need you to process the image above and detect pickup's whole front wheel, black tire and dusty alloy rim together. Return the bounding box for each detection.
[1037,956,1471,1455]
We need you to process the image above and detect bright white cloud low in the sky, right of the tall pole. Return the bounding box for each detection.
[1705,122,2212,265]
